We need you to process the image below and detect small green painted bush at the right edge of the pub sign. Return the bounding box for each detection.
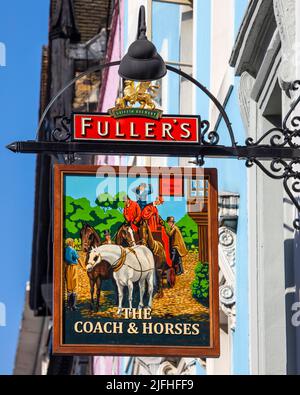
[191,262,209,307]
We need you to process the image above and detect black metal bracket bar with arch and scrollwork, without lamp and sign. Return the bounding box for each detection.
[7,61,300,230]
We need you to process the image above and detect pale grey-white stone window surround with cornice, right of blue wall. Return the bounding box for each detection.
[230,0,300,374]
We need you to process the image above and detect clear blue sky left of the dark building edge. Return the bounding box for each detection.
[0,0,49,374]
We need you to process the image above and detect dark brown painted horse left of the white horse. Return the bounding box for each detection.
[80,223,113,311]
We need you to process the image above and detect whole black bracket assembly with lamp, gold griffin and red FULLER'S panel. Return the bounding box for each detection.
[7,6,300,231]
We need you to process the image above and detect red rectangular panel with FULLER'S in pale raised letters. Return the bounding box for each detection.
[73,114,200,144]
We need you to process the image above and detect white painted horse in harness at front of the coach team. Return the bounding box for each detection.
[87,244,155,314]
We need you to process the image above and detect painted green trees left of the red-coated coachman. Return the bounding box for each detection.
[64,192,126,240]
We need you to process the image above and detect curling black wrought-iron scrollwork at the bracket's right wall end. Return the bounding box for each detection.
[246,81,300,231]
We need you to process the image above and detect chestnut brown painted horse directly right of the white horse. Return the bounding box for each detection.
[139,221,175,297]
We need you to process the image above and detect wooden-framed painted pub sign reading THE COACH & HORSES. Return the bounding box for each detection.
[54,165,219,357]
